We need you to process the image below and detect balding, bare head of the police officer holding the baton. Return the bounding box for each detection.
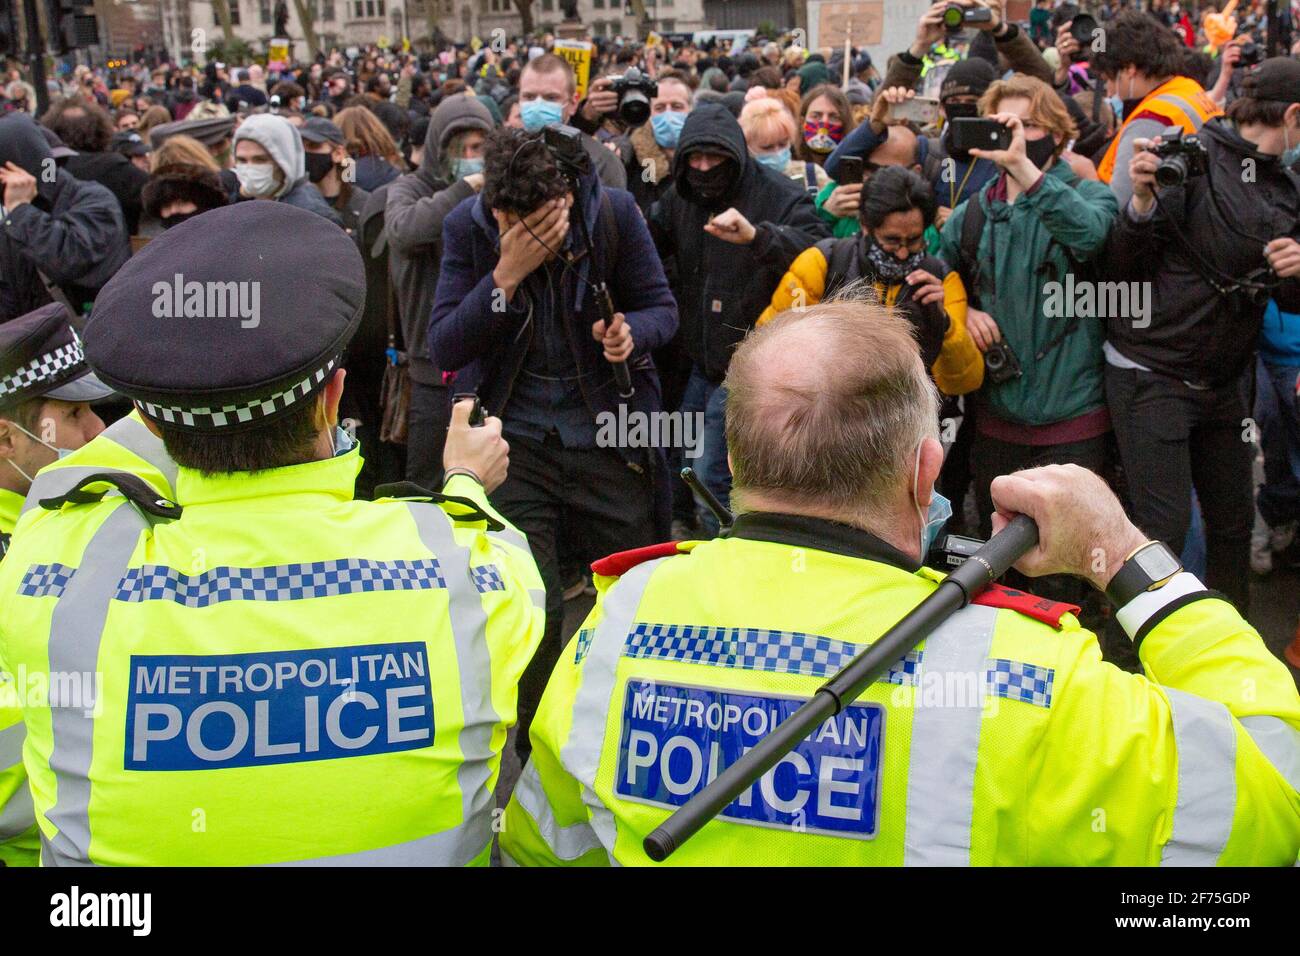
[727,298,939,527]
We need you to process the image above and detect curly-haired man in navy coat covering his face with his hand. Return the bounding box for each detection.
[429,126,677,754]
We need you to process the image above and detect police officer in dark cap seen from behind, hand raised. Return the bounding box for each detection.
[0,203,543,865]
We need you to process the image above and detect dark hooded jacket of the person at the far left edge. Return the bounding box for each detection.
[0,113,131,321]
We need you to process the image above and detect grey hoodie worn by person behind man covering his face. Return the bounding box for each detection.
[384,94,493,385]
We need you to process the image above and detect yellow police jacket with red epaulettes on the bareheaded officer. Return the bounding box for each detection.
[501,514,1300,866]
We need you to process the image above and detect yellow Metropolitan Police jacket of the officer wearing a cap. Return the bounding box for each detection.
[0,415,545,865]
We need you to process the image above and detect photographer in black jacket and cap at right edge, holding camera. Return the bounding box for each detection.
[1105,57,1300,613]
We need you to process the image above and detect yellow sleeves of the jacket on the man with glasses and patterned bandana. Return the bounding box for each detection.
[755,246,984,395]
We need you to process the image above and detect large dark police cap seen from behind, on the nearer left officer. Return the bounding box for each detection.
[85,200,365,433]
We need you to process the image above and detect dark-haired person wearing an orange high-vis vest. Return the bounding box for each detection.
[1089,10,1221,208]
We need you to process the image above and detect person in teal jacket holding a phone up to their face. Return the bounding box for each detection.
[940,74,1118,536]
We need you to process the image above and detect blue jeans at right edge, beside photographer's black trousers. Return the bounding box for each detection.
[1255,360,1300,528]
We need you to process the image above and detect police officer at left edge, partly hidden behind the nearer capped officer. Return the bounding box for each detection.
[0,303,113,866]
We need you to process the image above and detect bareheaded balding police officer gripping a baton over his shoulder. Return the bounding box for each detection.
[501,303,1300,865]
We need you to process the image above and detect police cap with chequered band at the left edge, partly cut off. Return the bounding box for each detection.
[0,302,113,408]
